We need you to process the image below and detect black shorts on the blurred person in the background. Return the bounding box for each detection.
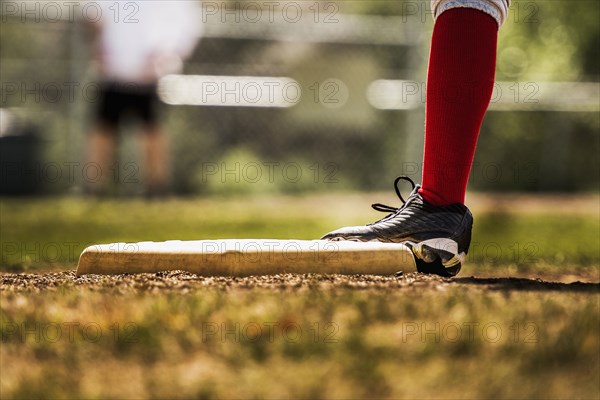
[96,82,160,129]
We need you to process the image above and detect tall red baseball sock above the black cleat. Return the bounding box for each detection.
[419,8,498,205]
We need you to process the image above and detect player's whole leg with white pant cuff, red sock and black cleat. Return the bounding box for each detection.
[323,0,508,275]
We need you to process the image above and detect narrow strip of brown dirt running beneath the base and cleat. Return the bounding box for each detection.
[0,271,600,293]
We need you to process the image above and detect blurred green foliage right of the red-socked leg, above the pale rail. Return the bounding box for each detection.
[497,0,600,81]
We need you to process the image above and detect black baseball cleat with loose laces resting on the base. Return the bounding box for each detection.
[322,176,473,276]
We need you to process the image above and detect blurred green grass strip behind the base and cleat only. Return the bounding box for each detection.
[0,194,600,279]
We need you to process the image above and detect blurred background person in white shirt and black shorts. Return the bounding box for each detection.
[86,1,201,197]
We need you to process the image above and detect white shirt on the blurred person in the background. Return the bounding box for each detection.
[99,0,201,82]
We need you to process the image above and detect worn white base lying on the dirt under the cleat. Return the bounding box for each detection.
[77,239,417,276]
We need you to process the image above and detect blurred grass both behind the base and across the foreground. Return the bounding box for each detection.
[0,195,600,399]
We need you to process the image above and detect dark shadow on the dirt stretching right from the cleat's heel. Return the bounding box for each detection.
[452,276,600,293]
